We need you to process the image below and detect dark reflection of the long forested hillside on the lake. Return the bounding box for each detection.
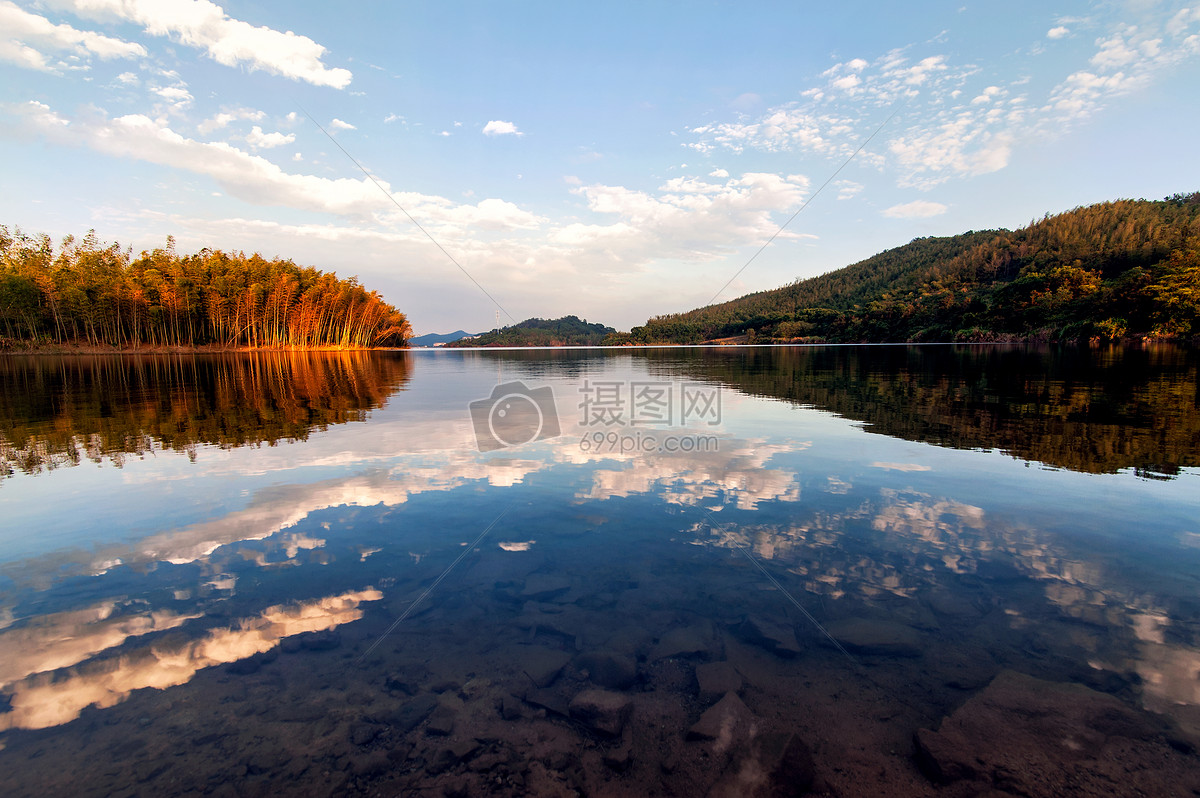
[646,344,1200,478]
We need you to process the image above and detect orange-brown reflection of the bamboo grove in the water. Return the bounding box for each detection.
[0,352,409,476]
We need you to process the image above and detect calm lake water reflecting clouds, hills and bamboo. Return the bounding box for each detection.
[0,346,1200,796]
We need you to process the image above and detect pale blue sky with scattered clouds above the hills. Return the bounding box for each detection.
[0,0,1200,335]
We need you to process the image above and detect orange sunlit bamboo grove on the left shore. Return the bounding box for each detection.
[0,226,412,348]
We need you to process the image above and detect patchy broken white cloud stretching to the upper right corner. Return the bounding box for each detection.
[684,6,1200,190]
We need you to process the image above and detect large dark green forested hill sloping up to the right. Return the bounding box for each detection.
[607,192,1200,343]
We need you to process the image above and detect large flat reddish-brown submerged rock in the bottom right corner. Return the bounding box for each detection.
[913,671,1200,797]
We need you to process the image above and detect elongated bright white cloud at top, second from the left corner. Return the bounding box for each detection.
[57,0,353,89]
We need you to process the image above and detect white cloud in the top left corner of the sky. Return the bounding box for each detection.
[0,0,146,72]
